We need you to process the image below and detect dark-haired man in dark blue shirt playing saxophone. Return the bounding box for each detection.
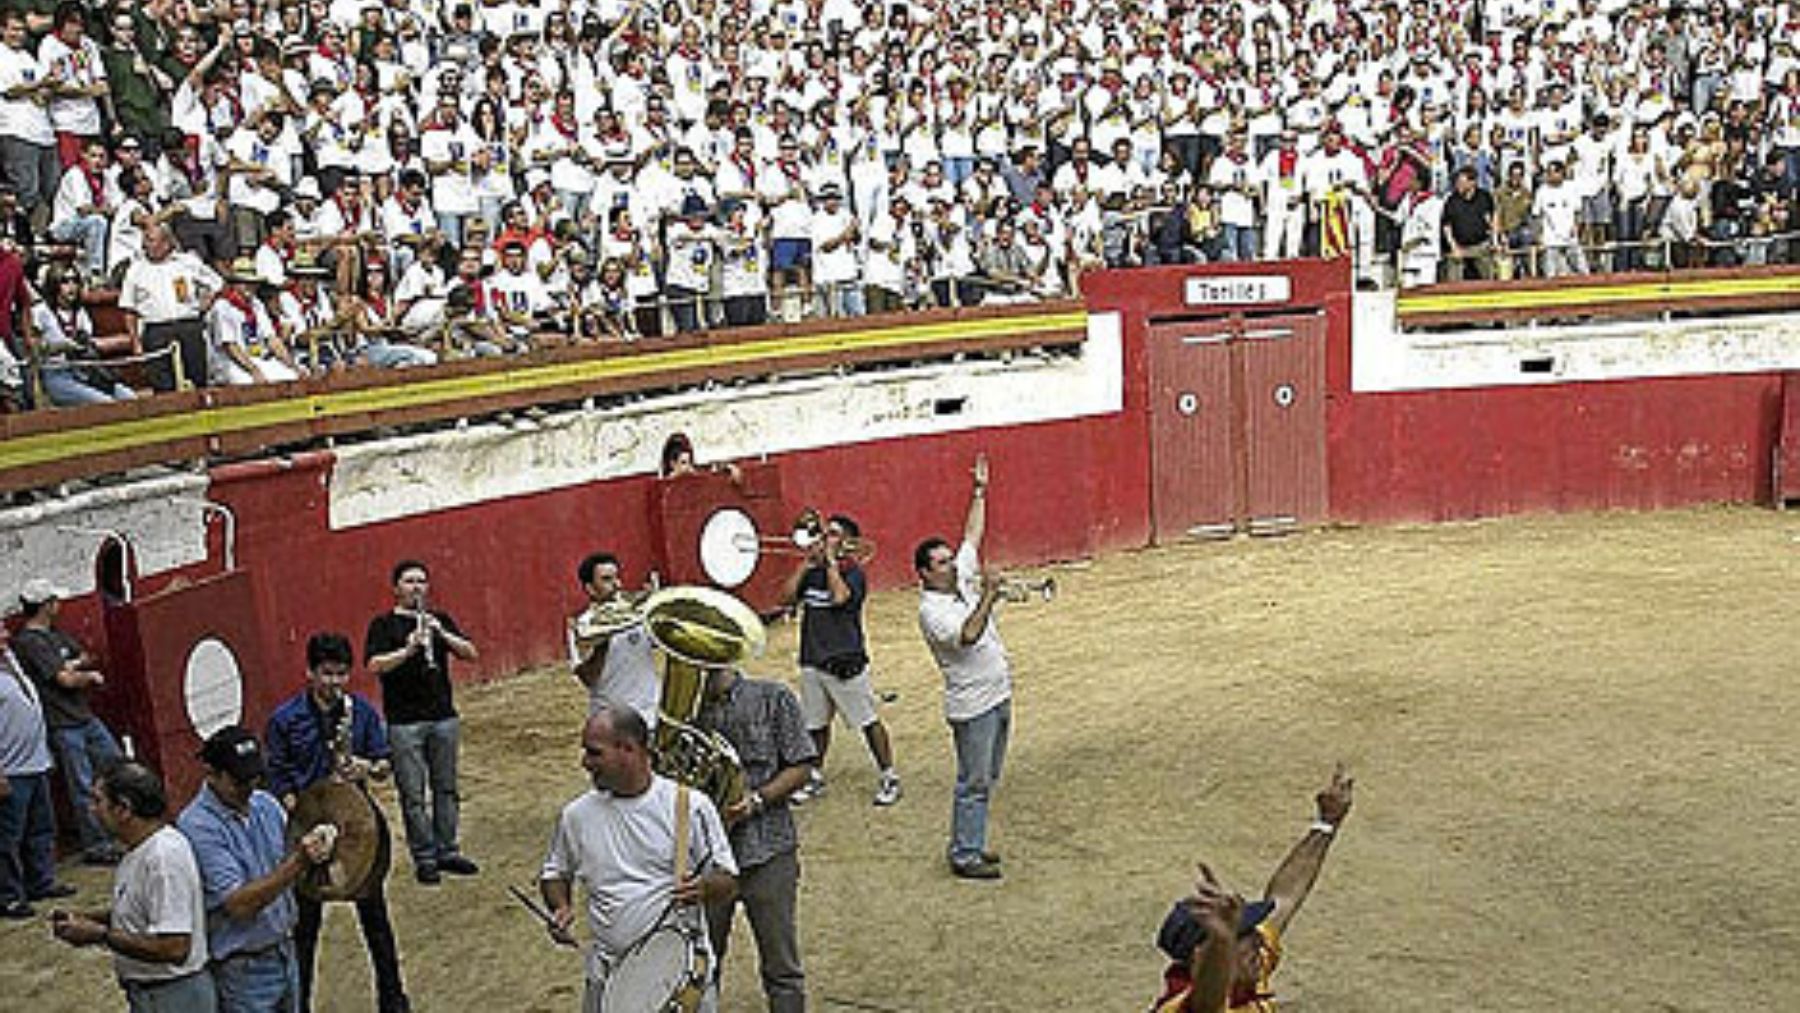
[263,633,412,1013]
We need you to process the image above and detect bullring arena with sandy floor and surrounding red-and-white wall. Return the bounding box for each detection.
[14,251,1800,1011]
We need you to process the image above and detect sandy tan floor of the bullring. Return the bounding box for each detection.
[0,509,1800,1013]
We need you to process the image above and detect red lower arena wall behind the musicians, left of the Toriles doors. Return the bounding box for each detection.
[189,401,1148,723]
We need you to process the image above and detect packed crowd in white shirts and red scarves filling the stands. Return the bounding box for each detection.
[0,0,1800,403]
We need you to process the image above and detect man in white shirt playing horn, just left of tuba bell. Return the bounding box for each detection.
[569,552,662,732]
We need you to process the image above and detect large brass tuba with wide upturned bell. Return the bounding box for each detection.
[641,587,769,810]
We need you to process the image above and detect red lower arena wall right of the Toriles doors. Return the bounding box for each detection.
[1328,374,1782,522]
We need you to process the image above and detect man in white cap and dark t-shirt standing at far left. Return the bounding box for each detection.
[13,578,124,865]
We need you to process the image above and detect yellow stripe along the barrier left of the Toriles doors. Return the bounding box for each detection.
[0,309,1087,471]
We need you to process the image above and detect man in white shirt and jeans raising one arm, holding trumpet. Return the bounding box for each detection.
[913,455,1012,880]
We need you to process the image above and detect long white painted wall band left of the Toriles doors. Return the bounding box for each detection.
[329,313,1125,531]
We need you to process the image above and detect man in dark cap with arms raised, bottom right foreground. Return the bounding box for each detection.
[1152,765,1355,1013]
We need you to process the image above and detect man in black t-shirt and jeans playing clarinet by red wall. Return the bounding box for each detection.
[364,560,479,883]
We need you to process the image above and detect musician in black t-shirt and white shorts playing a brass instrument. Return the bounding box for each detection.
[781,513,900,806]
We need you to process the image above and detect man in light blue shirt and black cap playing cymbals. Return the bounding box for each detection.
[176,725,331,1013]
